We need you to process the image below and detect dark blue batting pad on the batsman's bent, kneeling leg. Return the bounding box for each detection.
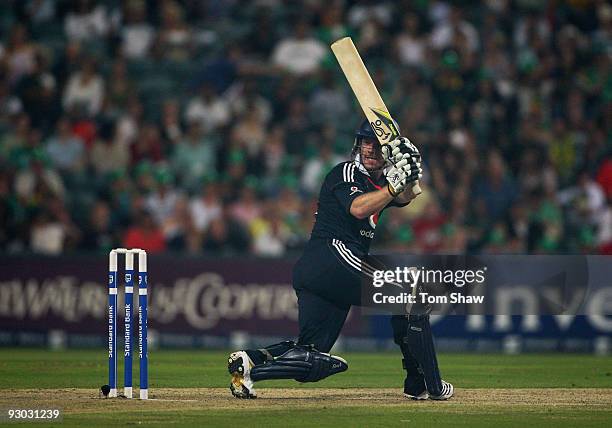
[251,346,348,382]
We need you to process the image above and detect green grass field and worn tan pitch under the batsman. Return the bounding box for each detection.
[0,348,612,427]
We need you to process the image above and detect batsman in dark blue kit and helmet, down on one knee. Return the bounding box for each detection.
[228,120,454,400]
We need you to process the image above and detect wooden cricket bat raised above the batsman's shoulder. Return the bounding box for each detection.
[331,37,421,196]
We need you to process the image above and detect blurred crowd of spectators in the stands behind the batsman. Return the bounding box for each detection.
[0,0,612,256]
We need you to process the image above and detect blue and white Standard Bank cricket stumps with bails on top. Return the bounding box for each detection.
[108,248,149,400]
